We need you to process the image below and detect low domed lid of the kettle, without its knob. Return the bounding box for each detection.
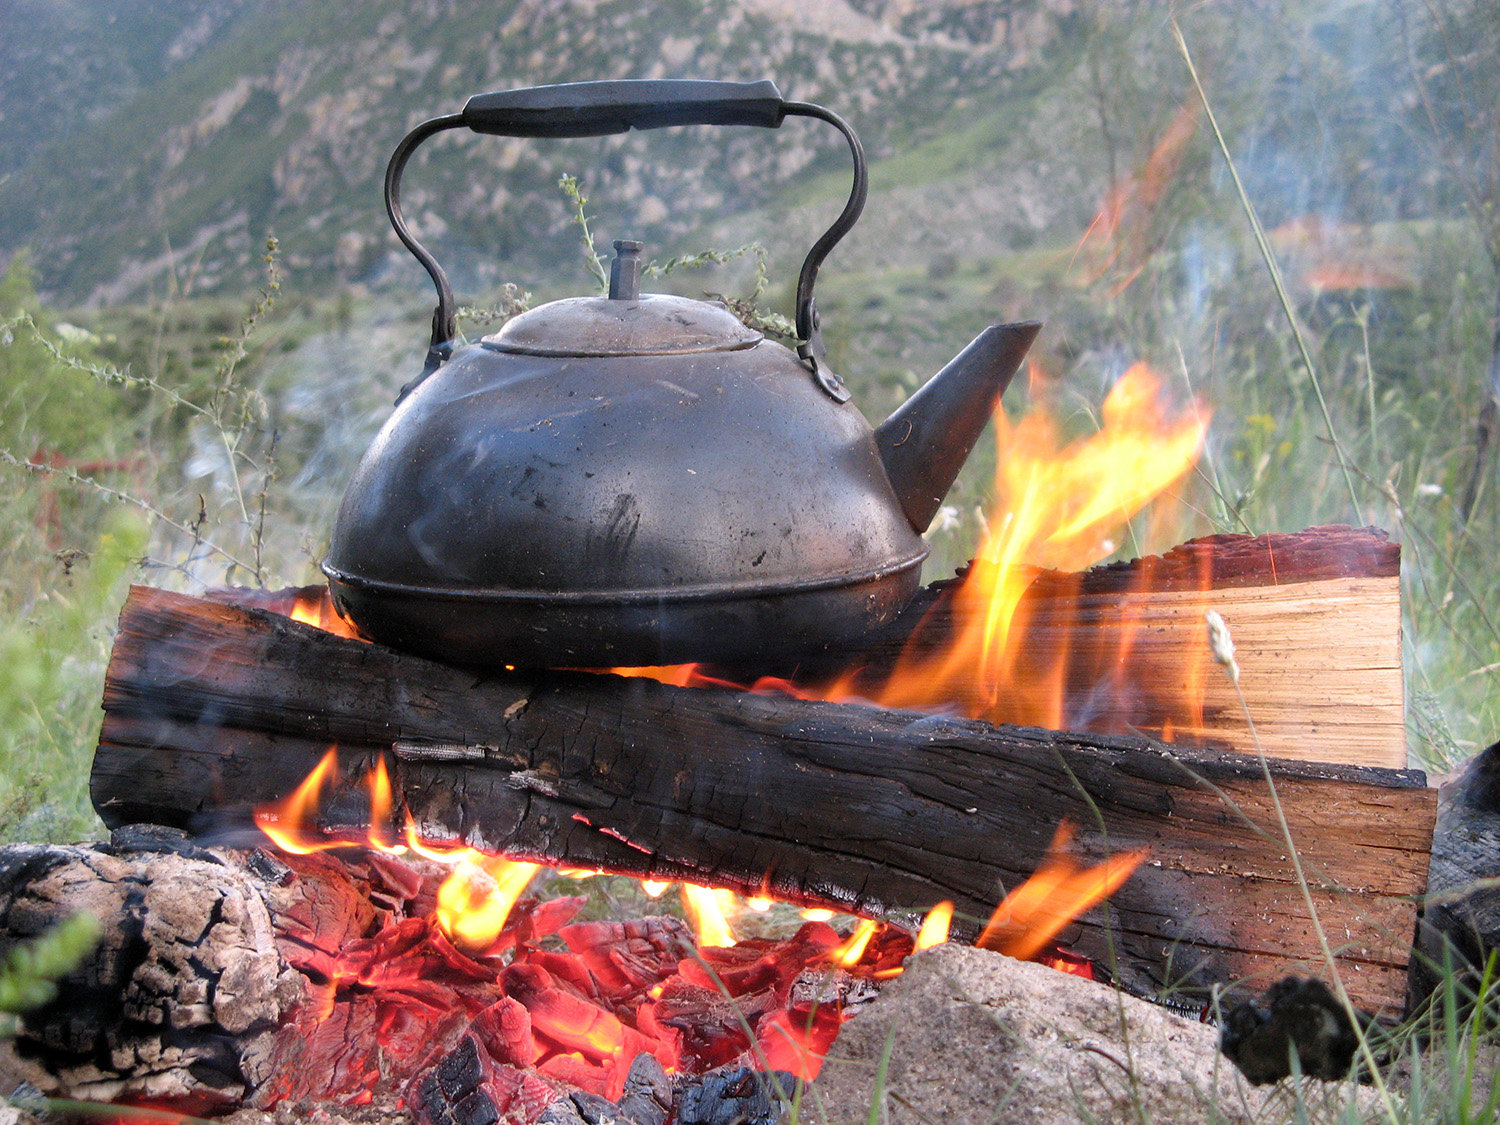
[480,293,765,356]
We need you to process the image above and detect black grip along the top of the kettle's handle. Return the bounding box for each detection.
[462,80,786,137]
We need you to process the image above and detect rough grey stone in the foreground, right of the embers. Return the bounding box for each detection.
[815,945,1370,1125]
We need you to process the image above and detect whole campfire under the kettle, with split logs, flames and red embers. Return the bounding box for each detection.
[20,351,1434,1125]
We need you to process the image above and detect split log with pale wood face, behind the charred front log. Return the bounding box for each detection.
[834,527,1407,770]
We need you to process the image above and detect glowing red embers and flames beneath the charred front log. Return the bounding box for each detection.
[234,741,1143,1121]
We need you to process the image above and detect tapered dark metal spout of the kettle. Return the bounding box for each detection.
[875,321,1041,534]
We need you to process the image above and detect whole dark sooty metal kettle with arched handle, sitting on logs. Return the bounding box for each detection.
[324,81,1038,678]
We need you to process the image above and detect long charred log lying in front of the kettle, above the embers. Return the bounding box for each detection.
[93,555,1434,1013]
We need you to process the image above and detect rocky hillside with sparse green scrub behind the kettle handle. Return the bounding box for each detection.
[0,0,1092,309]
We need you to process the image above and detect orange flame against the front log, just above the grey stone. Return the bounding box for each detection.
[975,821,1146,962]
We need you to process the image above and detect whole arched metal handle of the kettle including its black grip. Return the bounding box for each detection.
[386,78,869,366]
